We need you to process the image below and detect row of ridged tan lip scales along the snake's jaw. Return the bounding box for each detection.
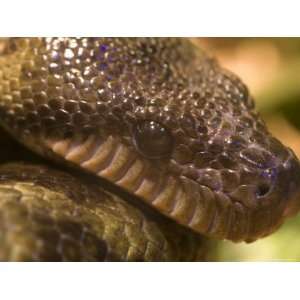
[36,135,284,241]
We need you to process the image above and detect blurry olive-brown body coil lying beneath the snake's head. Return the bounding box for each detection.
[0,163,207,261]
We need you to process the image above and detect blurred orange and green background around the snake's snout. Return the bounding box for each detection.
[194,38,300,261]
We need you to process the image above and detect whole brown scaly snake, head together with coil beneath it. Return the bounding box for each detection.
[0,37,300,261]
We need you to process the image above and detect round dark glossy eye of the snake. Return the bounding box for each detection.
[134,120,173,158]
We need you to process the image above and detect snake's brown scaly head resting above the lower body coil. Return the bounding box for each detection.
[0,38,300,242]
